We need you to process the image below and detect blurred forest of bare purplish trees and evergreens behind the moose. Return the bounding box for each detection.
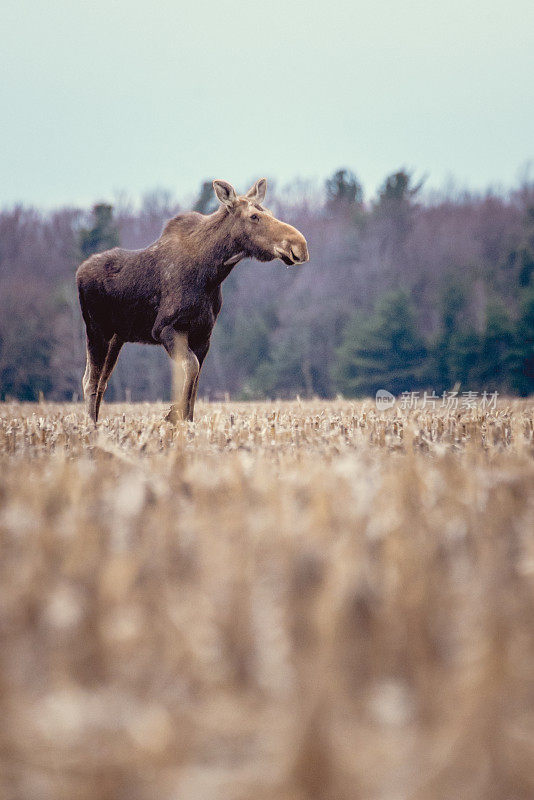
[0,169,534,401]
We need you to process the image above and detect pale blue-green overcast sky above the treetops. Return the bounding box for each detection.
[0,0,534,208]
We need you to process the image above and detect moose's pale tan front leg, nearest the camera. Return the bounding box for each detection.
[160,326,199,422]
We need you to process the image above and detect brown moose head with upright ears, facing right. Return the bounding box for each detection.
[213,178,309,266]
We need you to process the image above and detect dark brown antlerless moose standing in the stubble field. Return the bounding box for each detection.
[76,178,309,425]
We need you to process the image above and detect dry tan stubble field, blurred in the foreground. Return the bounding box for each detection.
[0,399,534,800]
